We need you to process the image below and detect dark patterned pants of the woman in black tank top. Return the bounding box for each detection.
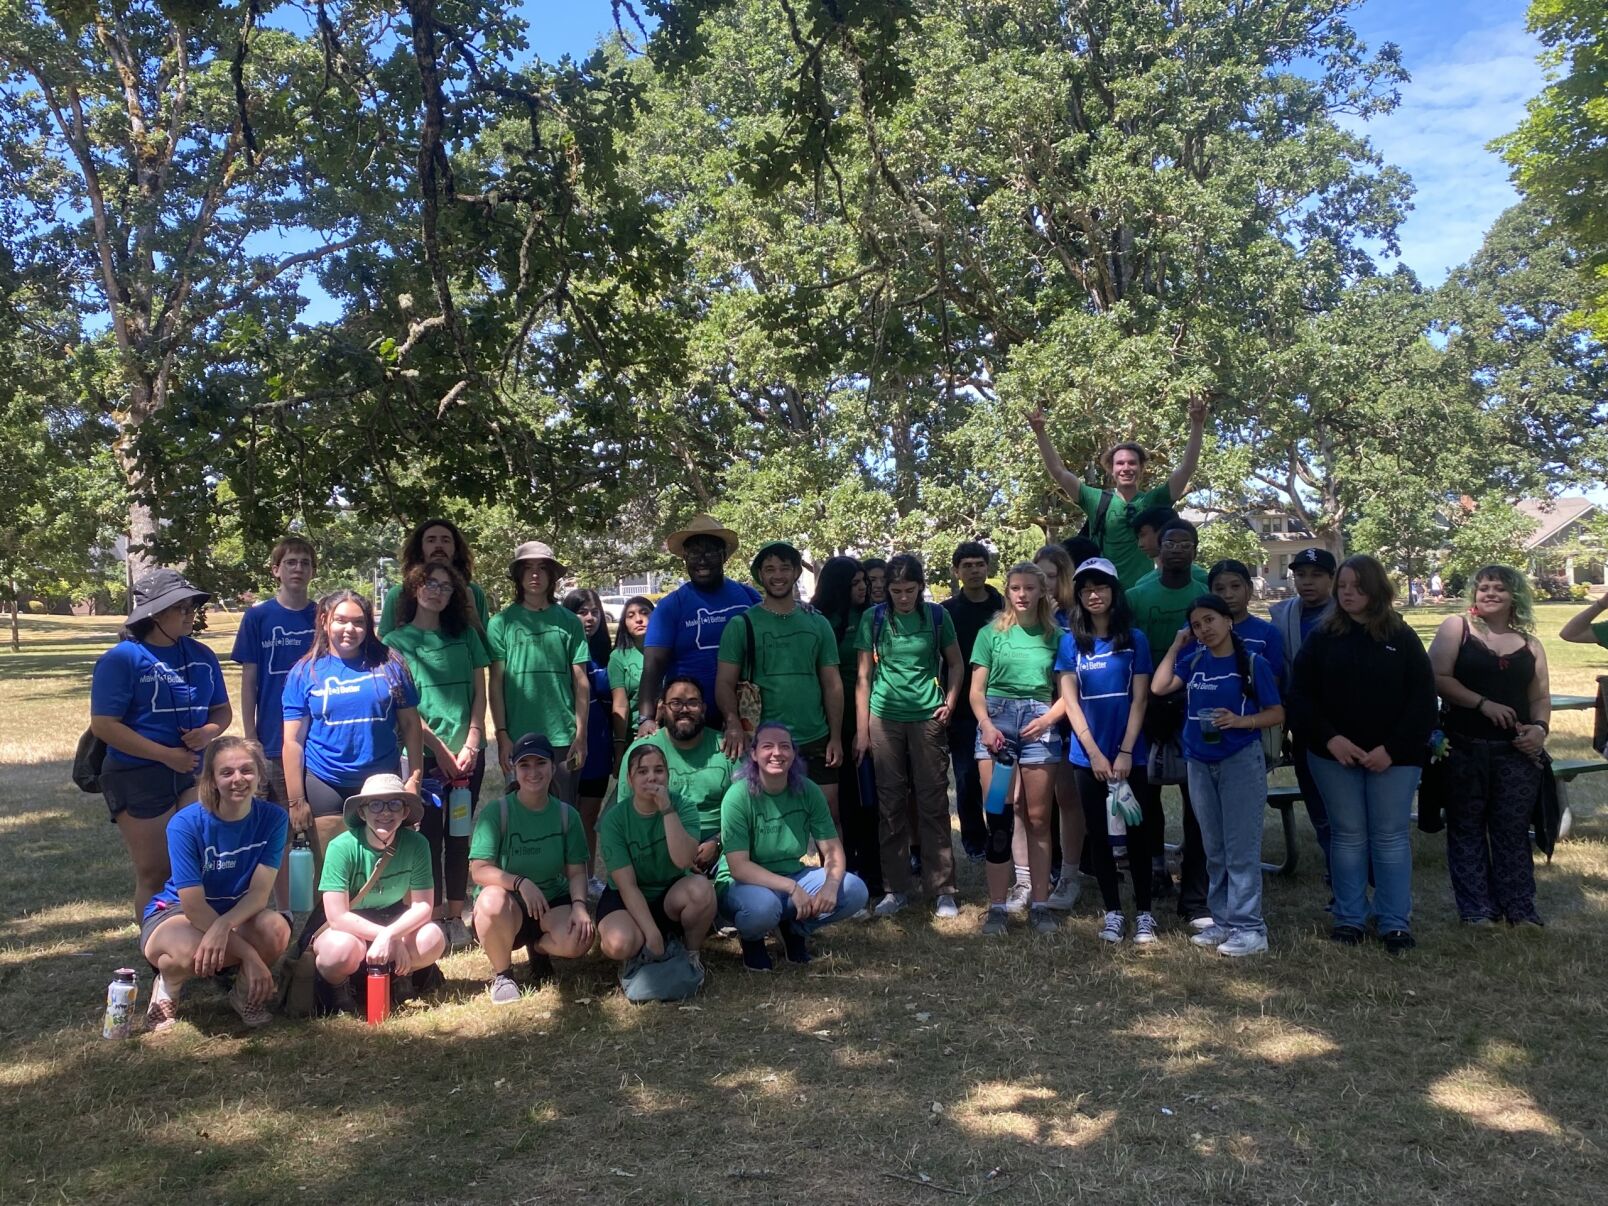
[1446,740,1540,925]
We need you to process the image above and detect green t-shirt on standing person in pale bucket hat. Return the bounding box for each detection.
[486,603,590,746]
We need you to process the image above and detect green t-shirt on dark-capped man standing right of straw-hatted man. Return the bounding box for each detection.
[720,605,841,746]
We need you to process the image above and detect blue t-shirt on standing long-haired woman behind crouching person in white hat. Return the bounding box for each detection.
[283,653,418,790]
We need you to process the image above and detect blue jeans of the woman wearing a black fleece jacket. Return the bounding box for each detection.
[1309,765,1423,934]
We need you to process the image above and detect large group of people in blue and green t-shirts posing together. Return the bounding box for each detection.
[92,407,1608,1028]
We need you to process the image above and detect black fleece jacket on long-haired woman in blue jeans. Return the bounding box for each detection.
[1290,621,1436,767]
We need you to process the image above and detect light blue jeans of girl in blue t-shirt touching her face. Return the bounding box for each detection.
[1187,741,1267,934]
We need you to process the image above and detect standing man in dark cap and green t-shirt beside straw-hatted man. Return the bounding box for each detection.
[716,540,843,822]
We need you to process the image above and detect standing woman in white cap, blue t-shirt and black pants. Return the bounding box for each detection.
[1055,556,1156,946]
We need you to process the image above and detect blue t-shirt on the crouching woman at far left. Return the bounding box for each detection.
[145,799,289,917]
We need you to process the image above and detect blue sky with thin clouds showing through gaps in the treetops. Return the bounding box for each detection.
[519,0,1542,285]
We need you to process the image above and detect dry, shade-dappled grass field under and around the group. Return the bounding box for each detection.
[0,606,1608,1203]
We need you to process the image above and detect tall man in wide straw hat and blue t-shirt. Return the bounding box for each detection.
[637,515,759,736]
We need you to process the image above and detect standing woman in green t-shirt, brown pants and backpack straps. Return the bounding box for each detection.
[854,553,963,918]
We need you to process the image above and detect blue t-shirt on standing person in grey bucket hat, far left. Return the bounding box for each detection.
[90,637,228,767]
